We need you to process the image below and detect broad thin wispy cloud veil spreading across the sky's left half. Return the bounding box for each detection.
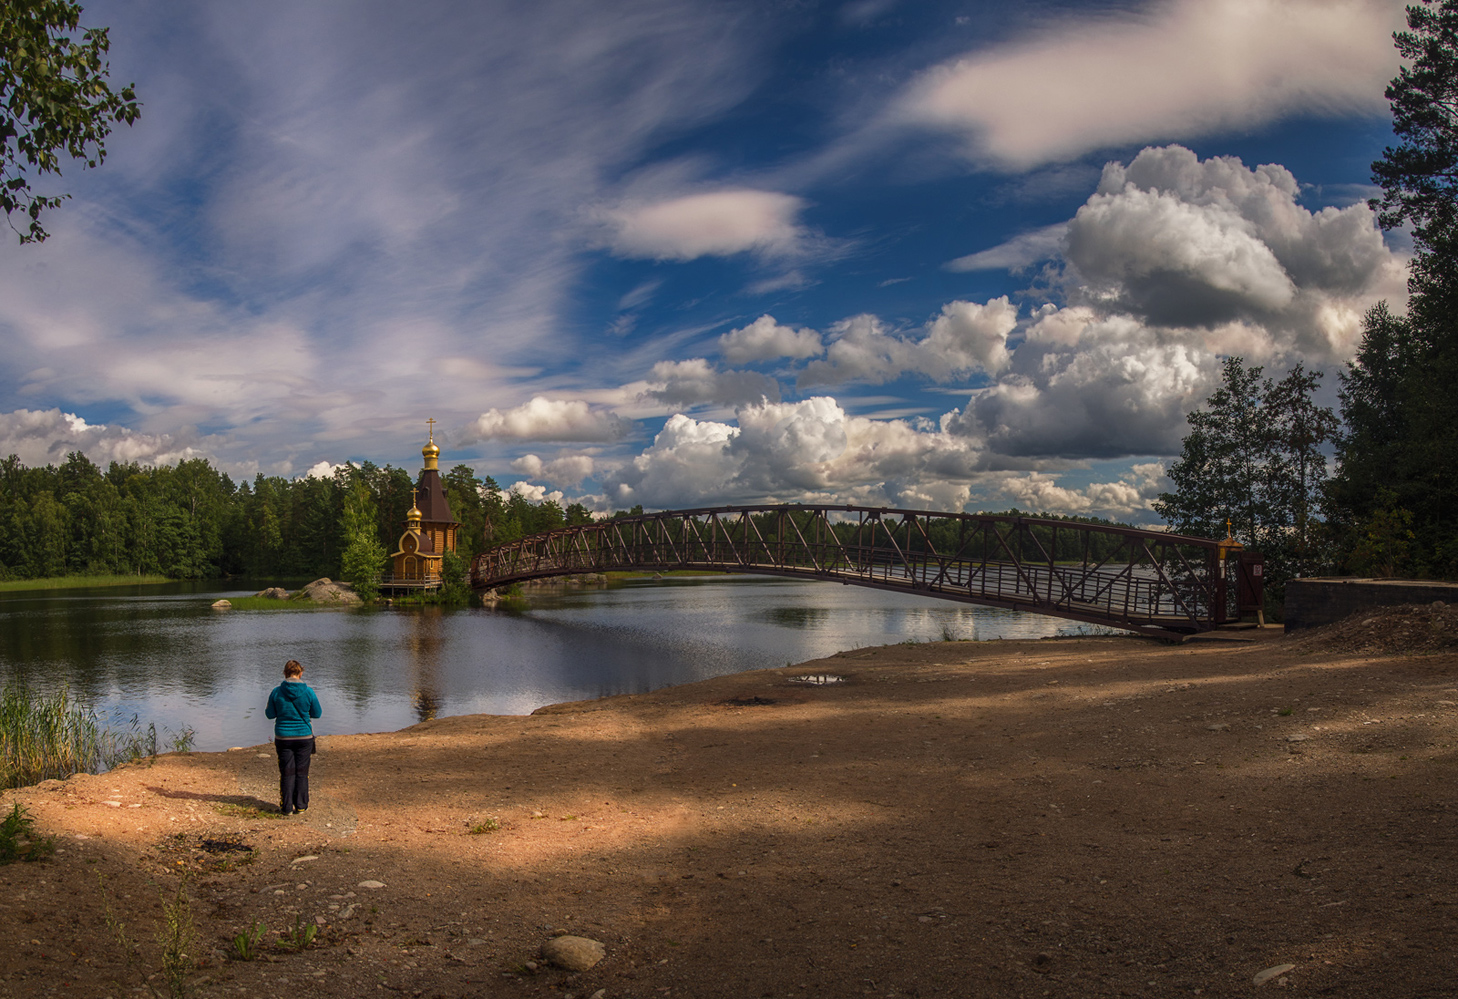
[0,0,765,470]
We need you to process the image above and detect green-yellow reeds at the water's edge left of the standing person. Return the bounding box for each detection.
[0,684,156,788]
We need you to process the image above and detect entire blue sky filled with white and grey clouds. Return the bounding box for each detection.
[0,0,1410,524]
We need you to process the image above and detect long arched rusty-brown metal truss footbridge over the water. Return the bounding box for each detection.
[471,505,1260,637]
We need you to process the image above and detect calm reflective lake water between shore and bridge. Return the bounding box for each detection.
[0,576,1101,750]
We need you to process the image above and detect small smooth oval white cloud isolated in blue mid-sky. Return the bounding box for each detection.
[599,188,809,261]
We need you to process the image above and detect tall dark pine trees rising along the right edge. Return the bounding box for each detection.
[1327,0,1458,576]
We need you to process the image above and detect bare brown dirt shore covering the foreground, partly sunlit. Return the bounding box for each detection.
[0,626,1458,999]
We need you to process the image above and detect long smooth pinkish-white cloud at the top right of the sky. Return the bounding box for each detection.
[889,0,1403,169]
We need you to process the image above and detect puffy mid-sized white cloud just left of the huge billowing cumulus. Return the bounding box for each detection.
[799,295,1018,385]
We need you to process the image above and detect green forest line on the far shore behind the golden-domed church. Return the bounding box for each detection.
[0,451,592,579]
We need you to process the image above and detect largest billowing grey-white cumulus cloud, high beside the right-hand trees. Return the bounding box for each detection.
[1064,146,1406,354]
